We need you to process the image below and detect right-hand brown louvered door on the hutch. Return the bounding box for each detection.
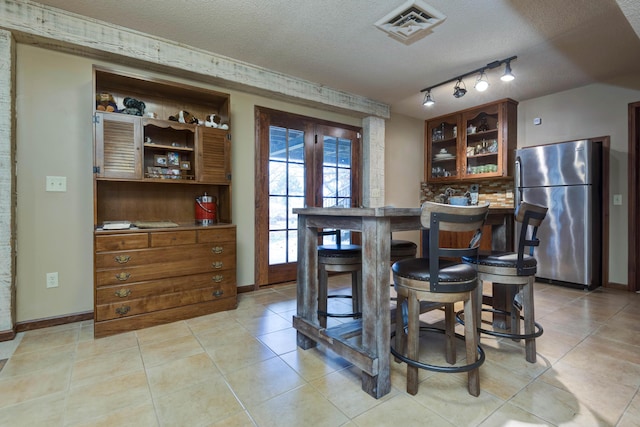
[196,127,231,184]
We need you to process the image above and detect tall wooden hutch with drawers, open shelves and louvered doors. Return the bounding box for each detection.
[94,67,237,337]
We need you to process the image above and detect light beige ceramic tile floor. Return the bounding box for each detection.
[0,276,640,427]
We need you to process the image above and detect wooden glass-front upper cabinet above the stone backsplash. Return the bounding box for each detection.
[425,99,518,182]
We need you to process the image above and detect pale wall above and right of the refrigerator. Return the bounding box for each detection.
[518,84,640,285]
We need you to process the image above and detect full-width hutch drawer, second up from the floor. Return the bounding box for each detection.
[96,270,237,305]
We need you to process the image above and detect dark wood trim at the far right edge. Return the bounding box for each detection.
[627,102,640,292]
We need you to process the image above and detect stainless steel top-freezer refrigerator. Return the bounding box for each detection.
[515,139,603,289]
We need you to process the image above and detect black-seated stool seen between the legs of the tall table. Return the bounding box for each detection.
[318,230,362,328]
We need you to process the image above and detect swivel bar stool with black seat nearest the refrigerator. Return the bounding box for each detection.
[456,202,547,363]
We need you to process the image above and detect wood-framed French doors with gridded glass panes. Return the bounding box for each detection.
[255,107,362,286]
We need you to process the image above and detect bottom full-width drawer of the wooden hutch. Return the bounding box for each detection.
[95,277,236,321]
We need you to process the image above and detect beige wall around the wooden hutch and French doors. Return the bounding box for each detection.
[16,44,361,322]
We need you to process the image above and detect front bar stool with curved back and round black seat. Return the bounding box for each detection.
[391,202,489,396]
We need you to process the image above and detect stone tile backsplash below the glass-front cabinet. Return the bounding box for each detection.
[420,178,514,208]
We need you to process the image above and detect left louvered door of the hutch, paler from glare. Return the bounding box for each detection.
[95,112,142,179]
